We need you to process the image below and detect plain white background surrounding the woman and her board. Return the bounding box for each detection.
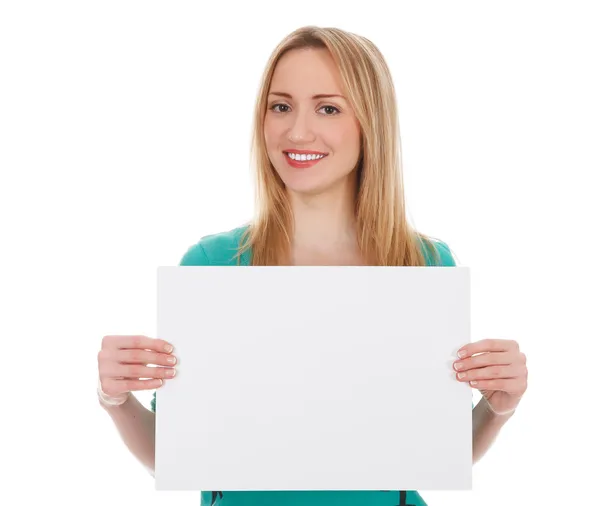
[0,0,600,506]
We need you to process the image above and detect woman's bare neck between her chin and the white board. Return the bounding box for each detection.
[290,178,356,251]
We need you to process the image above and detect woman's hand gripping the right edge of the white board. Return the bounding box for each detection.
[454,339,527,415]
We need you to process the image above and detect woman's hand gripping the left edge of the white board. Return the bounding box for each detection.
[98,335,177,402]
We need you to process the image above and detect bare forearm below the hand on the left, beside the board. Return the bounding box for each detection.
[100,395,156,476]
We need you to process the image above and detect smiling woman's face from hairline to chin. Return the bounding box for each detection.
[264,49,360,194]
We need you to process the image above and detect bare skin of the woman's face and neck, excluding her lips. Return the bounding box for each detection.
[264,49,362,265]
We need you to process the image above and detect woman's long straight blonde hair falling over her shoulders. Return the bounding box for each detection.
[238,26,440,266]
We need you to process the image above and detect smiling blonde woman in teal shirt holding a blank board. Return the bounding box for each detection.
[99,27,527,506]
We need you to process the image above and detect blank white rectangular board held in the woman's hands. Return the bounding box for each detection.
[155,266,472,491]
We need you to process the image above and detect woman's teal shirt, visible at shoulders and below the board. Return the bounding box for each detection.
[151,227,464,506]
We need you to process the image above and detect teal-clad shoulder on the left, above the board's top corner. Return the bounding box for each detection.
[179,225,248,265]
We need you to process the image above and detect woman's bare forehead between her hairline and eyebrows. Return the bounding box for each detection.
[270,48,342,98]
